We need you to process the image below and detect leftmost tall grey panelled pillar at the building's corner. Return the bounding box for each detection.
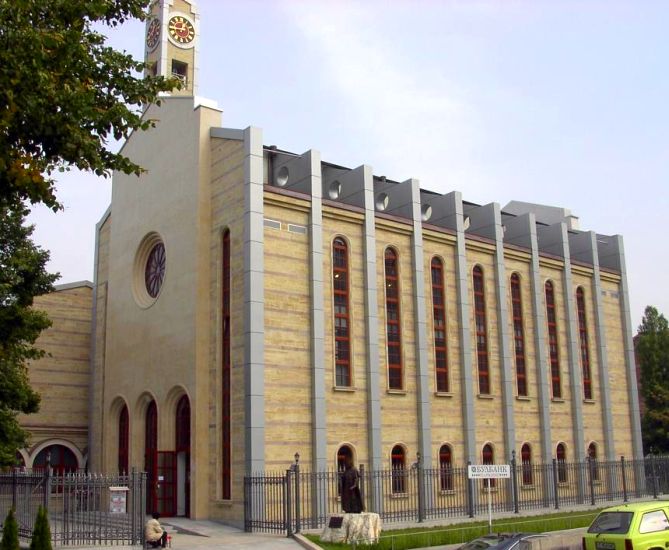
[243,127,265,473]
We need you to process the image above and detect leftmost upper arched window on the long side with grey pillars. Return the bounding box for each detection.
[332,237,351,387]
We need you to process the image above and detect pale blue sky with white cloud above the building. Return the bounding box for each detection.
[30,0,669,328]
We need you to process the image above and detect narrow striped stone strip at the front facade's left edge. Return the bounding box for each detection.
[88,213,112,472]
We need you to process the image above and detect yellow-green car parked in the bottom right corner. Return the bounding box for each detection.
[583,500,669,550]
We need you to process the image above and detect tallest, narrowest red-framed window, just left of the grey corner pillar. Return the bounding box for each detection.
[221,230,232,500]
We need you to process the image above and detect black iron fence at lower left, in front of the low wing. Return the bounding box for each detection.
[0,468,146,546]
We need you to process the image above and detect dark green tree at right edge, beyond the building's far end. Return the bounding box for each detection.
[636,306,669,453]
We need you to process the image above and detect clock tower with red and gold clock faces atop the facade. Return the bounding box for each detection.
[144,0,200,96]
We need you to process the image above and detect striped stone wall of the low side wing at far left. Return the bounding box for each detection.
[18,282,93,468]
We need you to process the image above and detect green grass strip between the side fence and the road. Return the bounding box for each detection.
[305,509,599,550]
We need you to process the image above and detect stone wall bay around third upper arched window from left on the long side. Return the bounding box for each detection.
[423,229,466,467]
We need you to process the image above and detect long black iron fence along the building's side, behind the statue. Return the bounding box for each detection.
[244,455,669,535]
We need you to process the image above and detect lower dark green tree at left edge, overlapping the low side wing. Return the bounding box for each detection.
[0,207,58,466]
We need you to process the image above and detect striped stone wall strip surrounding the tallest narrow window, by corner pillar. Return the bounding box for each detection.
[208,138,245,522]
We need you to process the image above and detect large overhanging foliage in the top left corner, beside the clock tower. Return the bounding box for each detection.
[0,0,179,210]
